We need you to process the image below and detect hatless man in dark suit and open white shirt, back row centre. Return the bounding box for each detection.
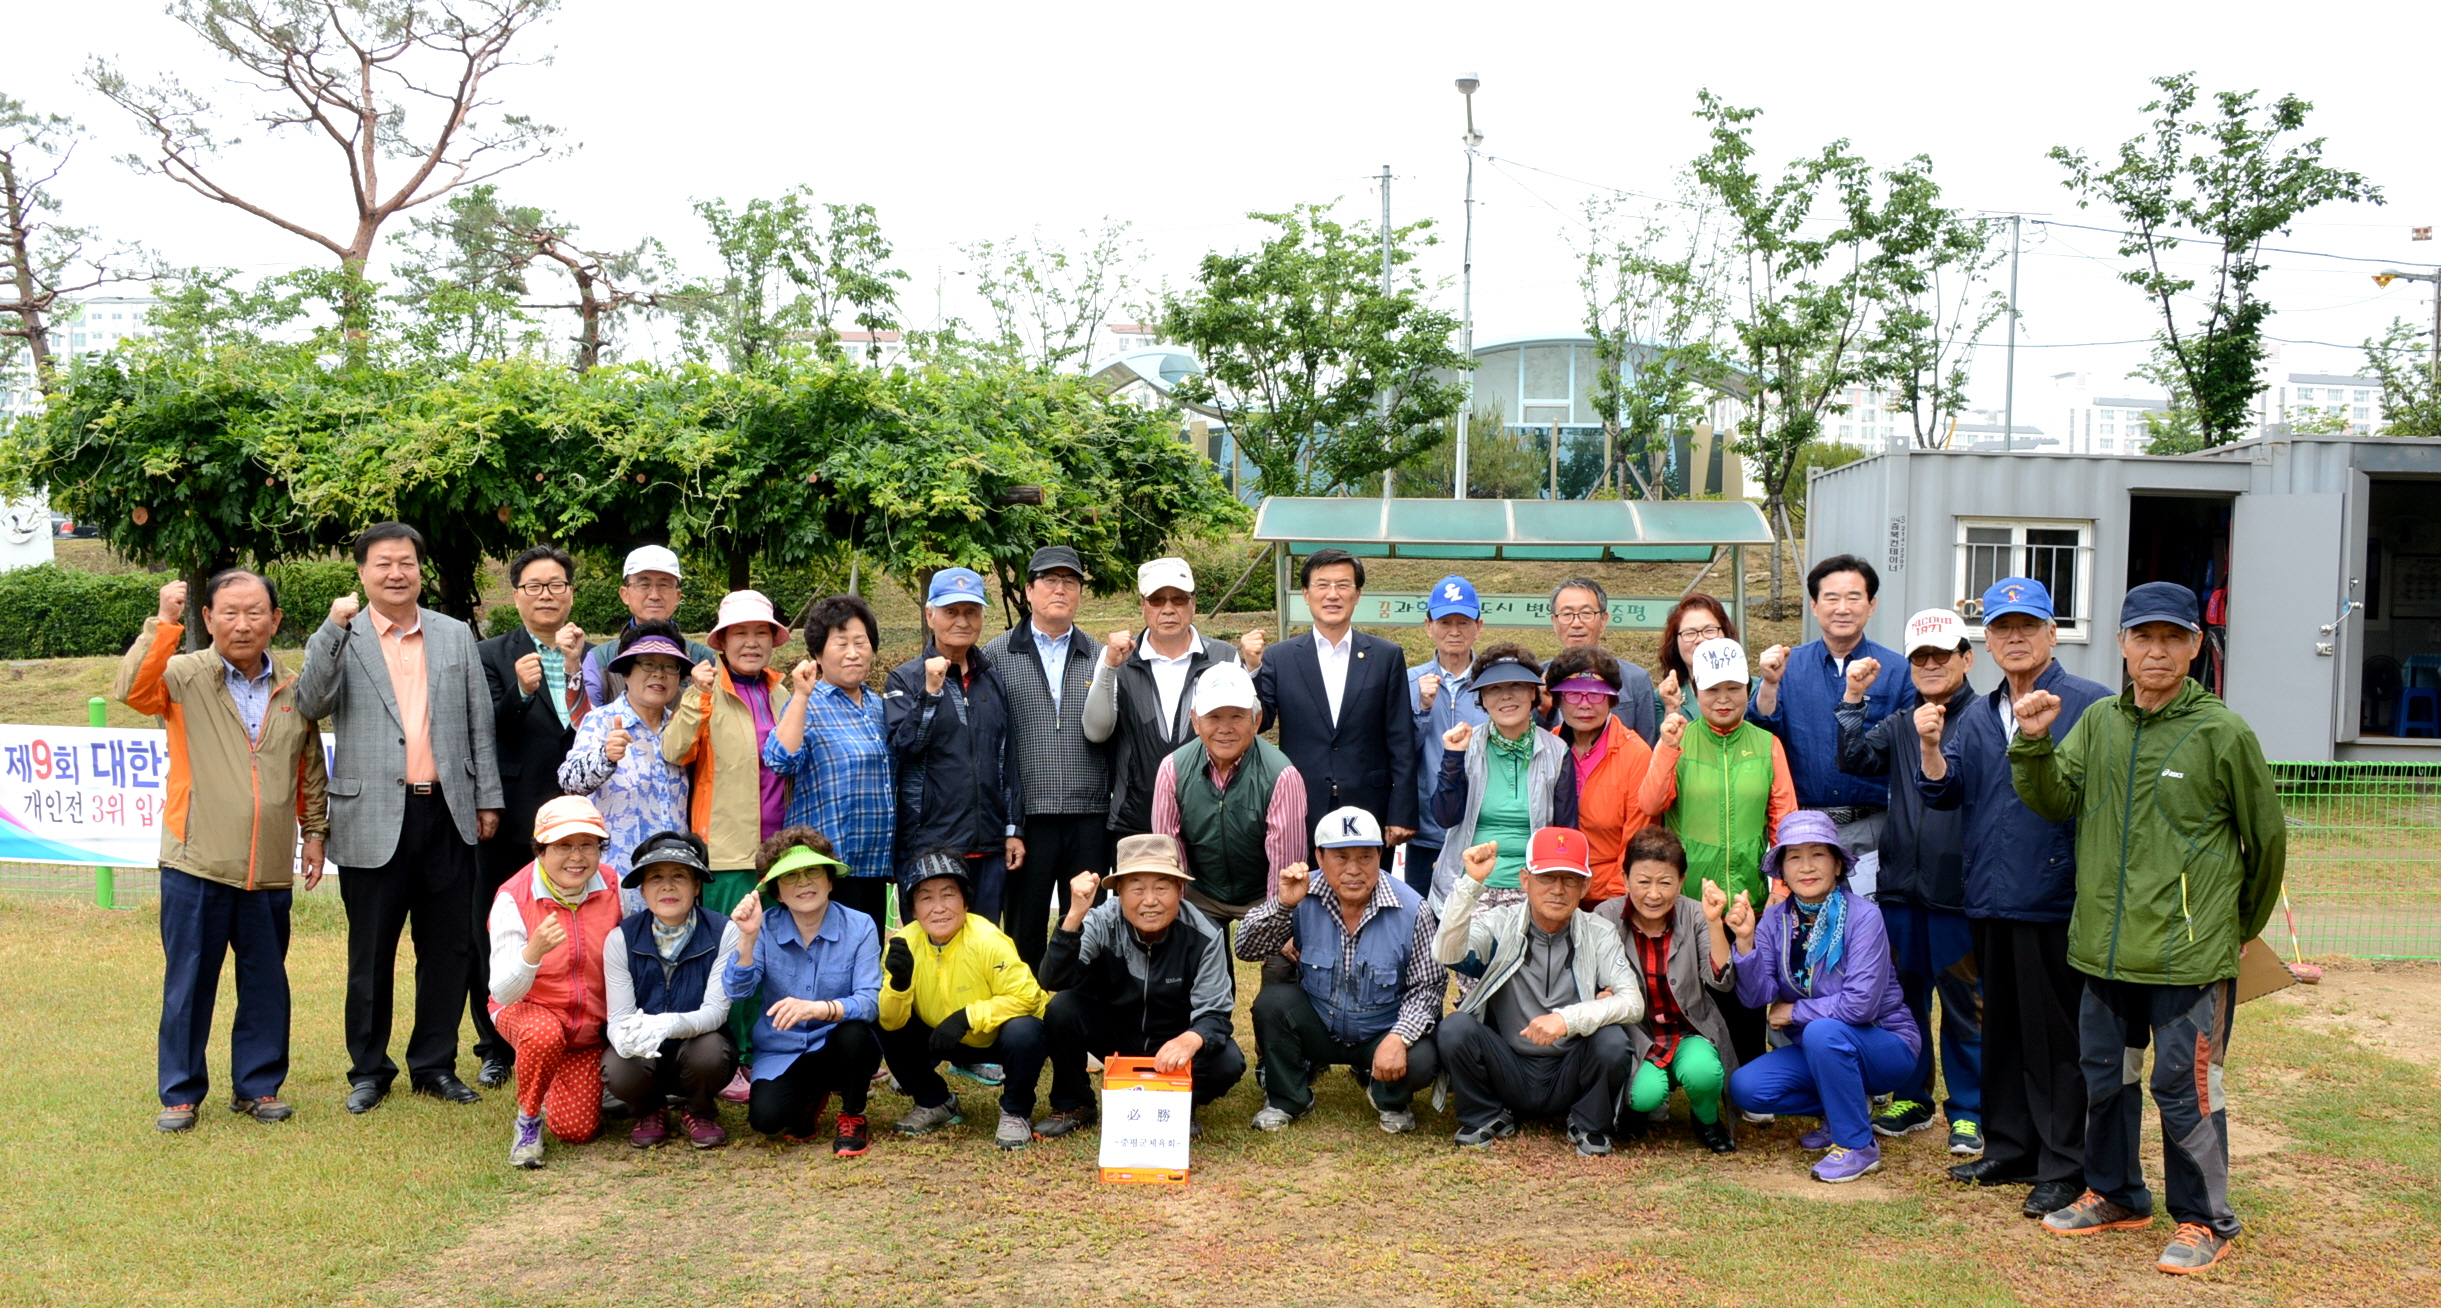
[1245,549,1418,844]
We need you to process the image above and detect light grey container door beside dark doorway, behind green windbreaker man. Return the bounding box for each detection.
[2229,491,2356,761]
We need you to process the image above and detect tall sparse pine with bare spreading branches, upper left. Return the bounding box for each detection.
[85,0,557,332]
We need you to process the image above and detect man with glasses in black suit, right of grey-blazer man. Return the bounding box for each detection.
[466,544,593,1086]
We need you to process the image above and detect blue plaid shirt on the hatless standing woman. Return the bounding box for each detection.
[764,681,898,876]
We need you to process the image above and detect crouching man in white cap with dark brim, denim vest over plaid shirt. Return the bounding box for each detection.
[1238,808,1450,1135]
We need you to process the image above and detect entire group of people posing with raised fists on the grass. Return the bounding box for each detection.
[120,522,2285,1271]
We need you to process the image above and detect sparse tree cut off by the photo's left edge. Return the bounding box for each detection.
[0,95,149,395]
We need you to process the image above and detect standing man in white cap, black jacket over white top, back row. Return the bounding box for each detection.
[1084,559,1260,839]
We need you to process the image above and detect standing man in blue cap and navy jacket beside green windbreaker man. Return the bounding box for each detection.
[1916,576,2111,1218]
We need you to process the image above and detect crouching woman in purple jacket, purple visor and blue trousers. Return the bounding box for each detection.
[1704,810,1921,1186]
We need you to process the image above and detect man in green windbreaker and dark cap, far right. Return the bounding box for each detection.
[2009,581,2287,1274]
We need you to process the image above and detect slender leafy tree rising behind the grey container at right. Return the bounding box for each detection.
[2050,73,2382,447]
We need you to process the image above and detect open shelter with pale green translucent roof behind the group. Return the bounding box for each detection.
[1255,495,1772,637]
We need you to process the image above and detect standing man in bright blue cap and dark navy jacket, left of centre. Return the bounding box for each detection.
[881,569,1025,922]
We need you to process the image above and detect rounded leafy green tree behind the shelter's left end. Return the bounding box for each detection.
[1162,205,1474,495]
